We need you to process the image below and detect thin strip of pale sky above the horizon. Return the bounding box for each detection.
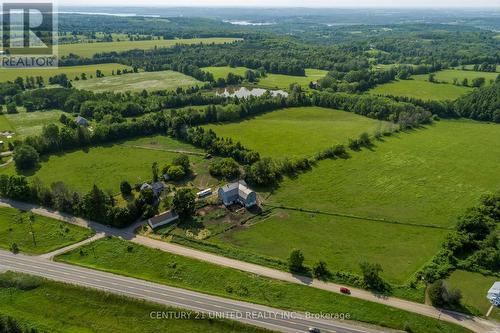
[58,0,500,8]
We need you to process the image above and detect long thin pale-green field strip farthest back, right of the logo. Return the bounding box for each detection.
[59,37,241,58]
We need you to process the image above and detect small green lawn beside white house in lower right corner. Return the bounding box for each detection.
[447,270,500,321]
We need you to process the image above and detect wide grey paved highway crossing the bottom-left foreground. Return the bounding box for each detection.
[0,250,383,333]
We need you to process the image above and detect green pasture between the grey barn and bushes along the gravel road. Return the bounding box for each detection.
[212,210,447,284]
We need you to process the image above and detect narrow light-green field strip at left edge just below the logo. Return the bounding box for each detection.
[0,64,132,85]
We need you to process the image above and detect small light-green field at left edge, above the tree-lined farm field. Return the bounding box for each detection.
[0,109,63,138]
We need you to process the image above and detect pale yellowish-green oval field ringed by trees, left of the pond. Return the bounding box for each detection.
[73,71,201,92]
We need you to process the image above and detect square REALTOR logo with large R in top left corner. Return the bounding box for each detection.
[0,2,57,68]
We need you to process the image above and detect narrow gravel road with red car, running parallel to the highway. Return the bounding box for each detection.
[0,198,500,333]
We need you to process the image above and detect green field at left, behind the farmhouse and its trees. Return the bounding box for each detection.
[0,136,216,193]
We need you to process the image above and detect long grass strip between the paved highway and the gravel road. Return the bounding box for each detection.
[57,238,467,333]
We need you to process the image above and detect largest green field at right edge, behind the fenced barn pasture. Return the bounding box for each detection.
[270,120,500,227]
